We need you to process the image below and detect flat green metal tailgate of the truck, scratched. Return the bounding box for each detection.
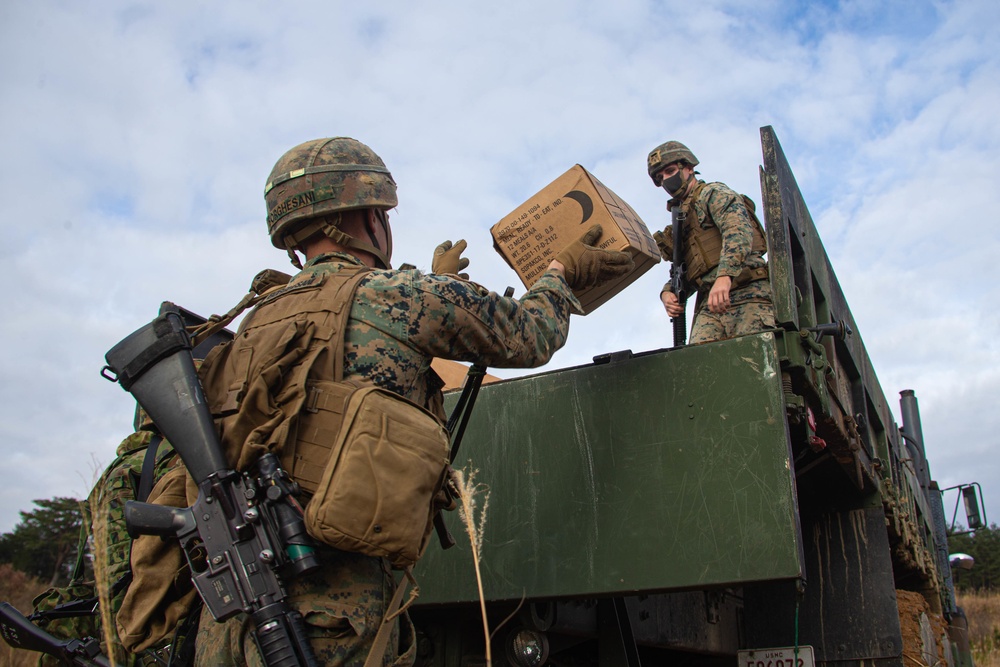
[417,333,802,604]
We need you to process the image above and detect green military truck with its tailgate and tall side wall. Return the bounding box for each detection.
[412,127,981,667]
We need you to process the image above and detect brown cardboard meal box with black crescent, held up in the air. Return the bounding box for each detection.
[490,165,660,313]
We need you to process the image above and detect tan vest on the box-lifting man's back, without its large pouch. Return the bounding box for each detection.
[199,265,370,494]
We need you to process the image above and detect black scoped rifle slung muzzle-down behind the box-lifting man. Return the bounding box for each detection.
[101,303,319,667]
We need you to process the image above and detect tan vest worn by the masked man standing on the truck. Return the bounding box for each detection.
[682,181,767,288]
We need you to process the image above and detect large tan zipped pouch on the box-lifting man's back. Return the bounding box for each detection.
[298,382,450,568]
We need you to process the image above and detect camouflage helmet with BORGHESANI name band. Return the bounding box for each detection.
[264,137,397,250]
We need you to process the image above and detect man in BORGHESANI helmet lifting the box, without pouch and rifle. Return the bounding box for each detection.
[196,137,632,665]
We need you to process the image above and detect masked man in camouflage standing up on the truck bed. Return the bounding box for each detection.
[646,141,774,344]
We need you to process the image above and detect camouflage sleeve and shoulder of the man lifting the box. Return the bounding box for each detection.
[344,260,583,404]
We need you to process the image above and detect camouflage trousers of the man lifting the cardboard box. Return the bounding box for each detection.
[195,546,416,667]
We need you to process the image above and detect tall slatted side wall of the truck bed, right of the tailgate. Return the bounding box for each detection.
[760,127,938,581]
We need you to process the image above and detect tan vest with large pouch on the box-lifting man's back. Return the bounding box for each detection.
[200,266,450,568]
